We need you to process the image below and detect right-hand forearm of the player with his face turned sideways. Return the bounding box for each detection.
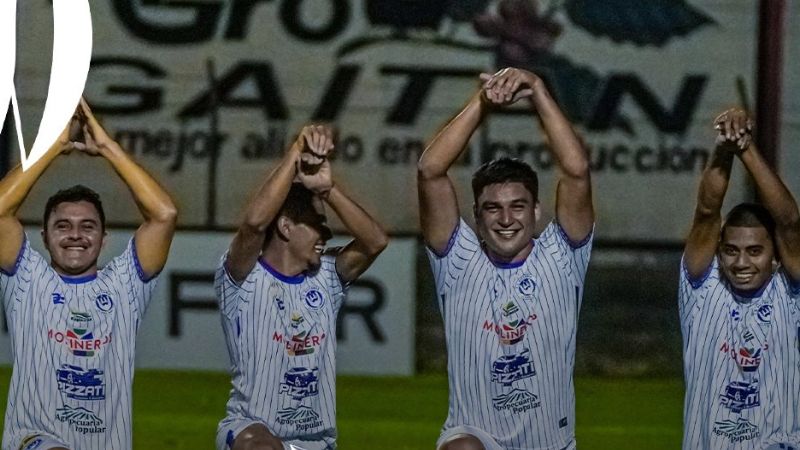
[325,185,388,255]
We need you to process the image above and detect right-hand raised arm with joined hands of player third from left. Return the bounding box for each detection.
[484,68,594,242]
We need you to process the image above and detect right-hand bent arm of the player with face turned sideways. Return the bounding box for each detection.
[324,185,389,281]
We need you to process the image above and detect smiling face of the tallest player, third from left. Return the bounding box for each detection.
[475,182,538,262]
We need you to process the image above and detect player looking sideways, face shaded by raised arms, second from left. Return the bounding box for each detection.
[215,125,387,450]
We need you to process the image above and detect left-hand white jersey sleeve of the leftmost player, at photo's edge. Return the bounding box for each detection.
[0,235,49,314]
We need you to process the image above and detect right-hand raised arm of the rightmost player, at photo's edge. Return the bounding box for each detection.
[728,111,800,281]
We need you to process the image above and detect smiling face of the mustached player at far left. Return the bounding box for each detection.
[42,201,105,276]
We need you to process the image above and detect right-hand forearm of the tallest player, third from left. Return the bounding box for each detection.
[531,78,589,179]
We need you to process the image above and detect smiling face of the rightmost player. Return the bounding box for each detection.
[719,227,775,291]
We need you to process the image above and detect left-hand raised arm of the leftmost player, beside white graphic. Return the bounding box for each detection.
[0,119,78,272]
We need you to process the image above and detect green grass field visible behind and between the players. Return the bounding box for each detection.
[0,368,683,450]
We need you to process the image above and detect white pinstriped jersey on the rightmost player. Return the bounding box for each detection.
[678,258,797,450]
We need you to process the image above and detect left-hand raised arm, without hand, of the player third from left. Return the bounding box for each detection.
[417,91,487,253]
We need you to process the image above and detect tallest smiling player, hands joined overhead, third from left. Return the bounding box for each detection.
[418,68,594,450]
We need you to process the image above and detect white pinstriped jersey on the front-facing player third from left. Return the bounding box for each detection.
[428,220,592,450]
